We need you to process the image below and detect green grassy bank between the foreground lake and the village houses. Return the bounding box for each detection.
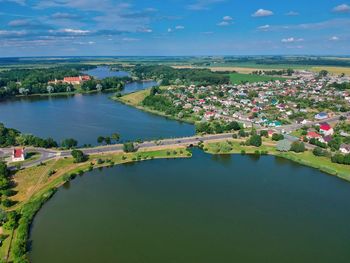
[204,140,350,182]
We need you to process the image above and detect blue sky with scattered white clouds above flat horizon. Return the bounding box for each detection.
[0,0,350,57]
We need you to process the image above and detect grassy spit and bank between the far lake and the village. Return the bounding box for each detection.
[115,87,195,124]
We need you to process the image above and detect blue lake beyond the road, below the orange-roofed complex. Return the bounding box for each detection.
[0,68,194,145]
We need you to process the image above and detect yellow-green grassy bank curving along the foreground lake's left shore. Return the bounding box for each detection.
[0,147,191,263]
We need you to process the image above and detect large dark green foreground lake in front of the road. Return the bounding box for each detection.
[30,150,350,263]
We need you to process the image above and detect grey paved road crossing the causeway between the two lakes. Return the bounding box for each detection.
[0,112,350,169]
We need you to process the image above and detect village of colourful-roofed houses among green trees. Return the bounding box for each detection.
[152,71,350,154]
